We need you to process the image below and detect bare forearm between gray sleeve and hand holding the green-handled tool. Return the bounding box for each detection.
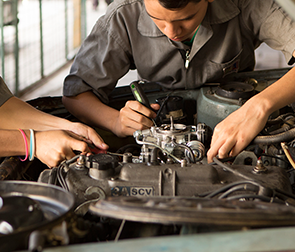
[63,92,119,133]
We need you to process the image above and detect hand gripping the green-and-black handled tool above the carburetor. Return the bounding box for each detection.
[115,101,160,137]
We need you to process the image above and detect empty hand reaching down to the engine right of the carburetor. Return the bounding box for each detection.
[207,96,268,163]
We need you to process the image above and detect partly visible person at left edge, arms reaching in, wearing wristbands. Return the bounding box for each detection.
[0,77,108,167]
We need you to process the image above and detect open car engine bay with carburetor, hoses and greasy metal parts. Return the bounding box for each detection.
[0,69,295,251]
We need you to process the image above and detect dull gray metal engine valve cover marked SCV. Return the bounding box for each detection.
[39,154,292,209]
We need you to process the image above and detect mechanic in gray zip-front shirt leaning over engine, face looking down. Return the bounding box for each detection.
[63,0,295,162]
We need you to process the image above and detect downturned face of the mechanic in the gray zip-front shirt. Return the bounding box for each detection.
[144,0,214,41]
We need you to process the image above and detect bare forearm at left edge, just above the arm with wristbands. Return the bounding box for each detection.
[0,97,70,130]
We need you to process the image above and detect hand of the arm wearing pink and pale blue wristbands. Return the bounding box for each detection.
[35,130,97,167]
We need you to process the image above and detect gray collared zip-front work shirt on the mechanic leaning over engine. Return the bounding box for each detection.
[63,0,295,103]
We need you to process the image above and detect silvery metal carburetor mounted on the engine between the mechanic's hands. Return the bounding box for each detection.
[134,117,207,164]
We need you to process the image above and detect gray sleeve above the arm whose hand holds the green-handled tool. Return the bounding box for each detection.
[63,4,136,103]
